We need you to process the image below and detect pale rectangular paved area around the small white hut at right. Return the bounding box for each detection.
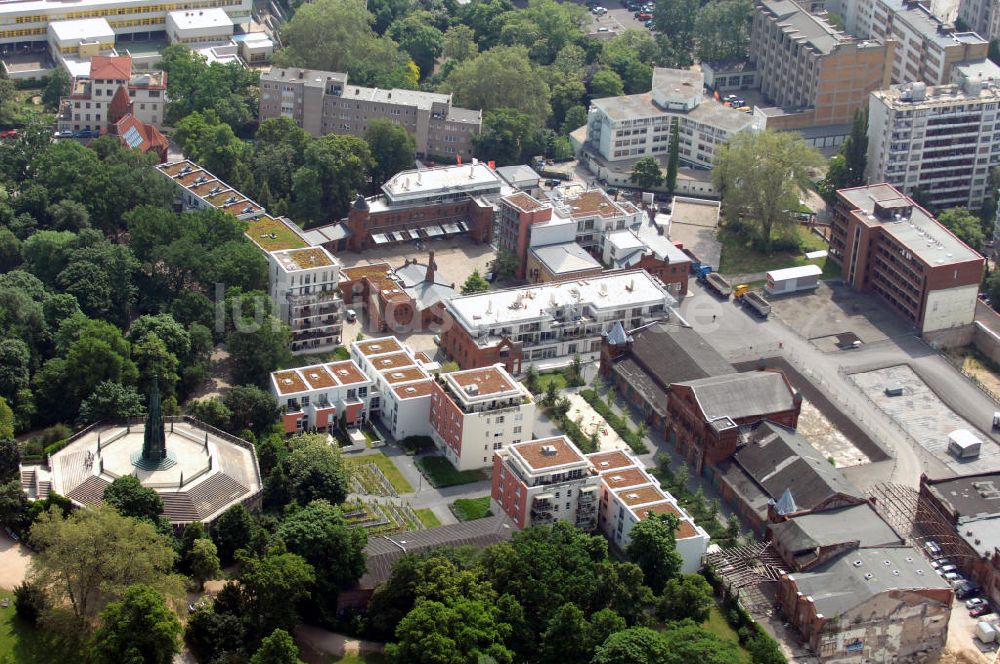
[850,365,1000,475]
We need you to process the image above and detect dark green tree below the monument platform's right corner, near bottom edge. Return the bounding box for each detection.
[238,551,316,639]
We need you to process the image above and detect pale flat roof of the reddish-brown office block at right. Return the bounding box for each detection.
[837,183,982,267]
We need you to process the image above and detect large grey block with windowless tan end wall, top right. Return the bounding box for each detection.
[750,0,893,134]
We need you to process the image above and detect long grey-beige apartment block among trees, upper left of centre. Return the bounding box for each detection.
[260,67,483,159]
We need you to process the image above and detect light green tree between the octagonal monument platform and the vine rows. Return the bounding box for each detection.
[286,435,349,505]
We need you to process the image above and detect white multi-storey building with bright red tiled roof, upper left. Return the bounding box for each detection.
[56,54,167,132]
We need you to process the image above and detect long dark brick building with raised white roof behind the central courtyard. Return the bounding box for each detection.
[308,160,511,252]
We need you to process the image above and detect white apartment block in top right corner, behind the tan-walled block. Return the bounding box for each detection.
[844,0,989,85]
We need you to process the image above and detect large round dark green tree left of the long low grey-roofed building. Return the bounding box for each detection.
[275,500,368,619]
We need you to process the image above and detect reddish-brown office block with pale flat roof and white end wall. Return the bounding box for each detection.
[829,184,983,334]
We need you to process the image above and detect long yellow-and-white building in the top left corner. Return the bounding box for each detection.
[0,0,253,50]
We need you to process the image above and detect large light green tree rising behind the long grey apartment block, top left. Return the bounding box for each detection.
[274,0,416,88]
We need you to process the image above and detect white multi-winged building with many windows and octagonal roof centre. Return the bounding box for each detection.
[585,67,753,168]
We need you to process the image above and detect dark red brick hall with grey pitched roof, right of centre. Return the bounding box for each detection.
[666,369,802,474]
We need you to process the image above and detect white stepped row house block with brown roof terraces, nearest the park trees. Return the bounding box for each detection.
[587,450,711,574]
